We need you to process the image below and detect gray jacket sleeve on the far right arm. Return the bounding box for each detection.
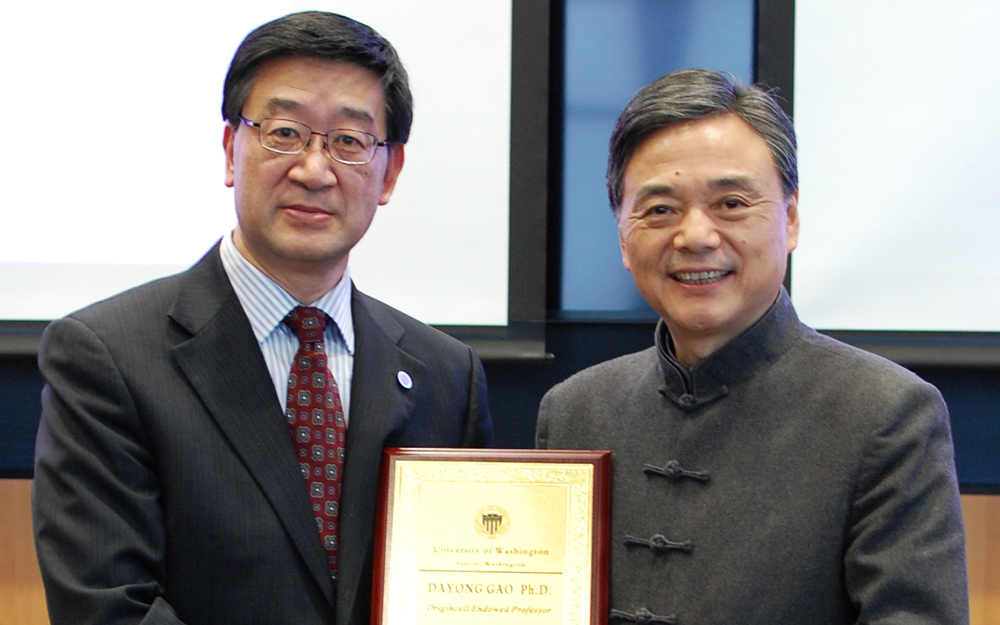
[844,385,969,625]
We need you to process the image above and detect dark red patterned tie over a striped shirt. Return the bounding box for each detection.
[285,306,347,579]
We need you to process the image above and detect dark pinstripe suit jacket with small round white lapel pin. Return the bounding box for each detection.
[33,247,492,625]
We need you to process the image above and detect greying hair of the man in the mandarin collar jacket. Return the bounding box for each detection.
[607,69,799,215]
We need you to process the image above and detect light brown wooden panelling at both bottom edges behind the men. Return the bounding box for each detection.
[0,480,1000,625]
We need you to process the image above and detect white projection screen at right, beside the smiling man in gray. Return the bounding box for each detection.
[791,0,1000,362]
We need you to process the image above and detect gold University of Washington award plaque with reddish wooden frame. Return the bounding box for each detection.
[372,449,611,625]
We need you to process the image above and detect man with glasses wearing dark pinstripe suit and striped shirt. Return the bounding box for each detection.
[33,12,492,625]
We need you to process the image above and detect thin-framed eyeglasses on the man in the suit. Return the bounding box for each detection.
[240,116,387,165]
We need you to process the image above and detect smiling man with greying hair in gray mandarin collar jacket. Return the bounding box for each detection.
[537,70,969,625]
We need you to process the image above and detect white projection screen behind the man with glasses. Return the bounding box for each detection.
[0,0,547,358]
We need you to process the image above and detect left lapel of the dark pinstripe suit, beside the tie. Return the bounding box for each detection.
[170,247,334,605]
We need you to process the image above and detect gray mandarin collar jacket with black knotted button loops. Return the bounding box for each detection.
[536,290,969,625]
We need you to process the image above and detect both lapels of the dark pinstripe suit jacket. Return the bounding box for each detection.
[169,245,416,622]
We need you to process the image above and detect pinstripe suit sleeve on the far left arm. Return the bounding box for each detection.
[32,318,188,625]
